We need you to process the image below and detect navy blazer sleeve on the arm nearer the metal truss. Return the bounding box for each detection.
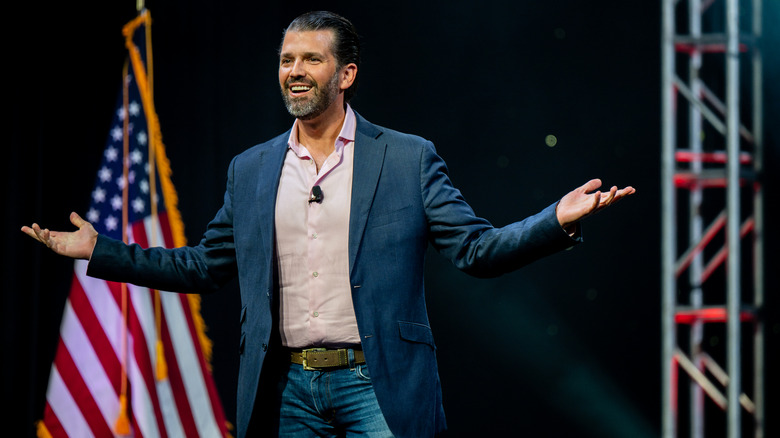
[420,142,582,277]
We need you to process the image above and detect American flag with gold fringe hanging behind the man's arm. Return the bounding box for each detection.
[38,11,229,438]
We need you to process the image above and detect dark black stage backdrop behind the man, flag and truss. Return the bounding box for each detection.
[0,0,780,437]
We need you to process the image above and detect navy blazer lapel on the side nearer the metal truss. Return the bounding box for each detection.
[349,112,387,274]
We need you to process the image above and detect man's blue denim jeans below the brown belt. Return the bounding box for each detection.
[279,351,393,438]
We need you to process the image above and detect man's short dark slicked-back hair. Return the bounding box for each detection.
[280,11,360,103]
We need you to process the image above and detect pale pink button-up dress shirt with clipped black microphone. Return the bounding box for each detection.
[275,106,360,348]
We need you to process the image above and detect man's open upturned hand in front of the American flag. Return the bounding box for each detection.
[22,213,98,260]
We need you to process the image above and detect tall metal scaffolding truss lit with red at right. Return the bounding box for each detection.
[661,0,764,438]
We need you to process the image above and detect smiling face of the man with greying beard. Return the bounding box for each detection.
[279,30,343,120]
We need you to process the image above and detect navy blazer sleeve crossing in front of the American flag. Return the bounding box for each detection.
[87,159,237,293]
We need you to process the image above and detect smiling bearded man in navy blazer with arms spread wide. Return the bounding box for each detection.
[22,12,634,437]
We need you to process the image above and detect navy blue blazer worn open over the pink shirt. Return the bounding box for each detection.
[88,115,579,438]
